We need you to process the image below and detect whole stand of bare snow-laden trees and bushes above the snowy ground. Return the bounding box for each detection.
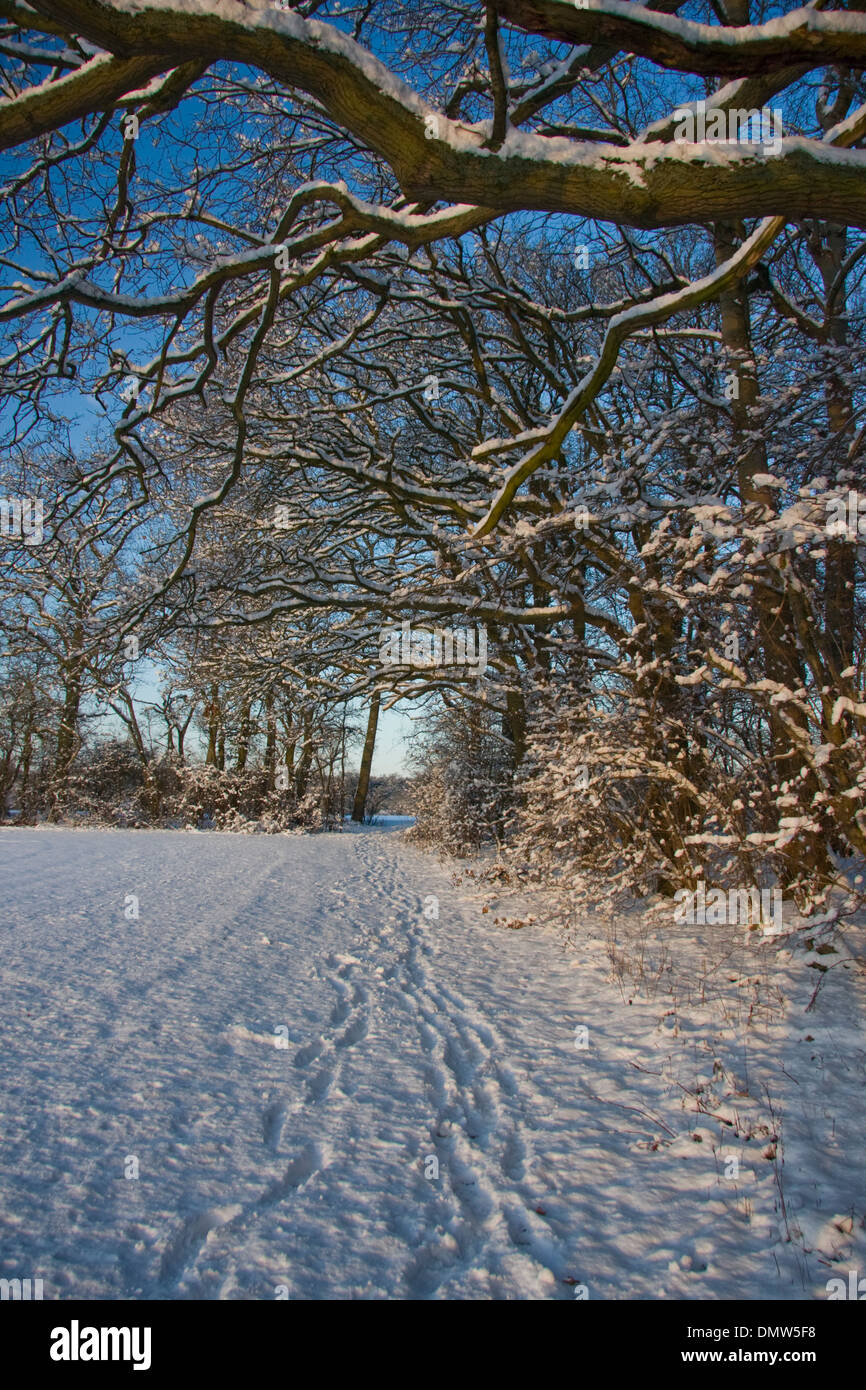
[0,0,866,915]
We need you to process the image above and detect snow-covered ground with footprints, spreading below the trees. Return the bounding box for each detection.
[0,828,866,1300]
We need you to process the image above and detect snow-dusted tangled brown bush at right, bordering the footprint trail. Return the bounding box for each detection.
[507,661,863,934]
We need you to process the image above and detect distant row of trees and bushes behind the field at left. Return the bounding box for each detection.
[0,617,407,831]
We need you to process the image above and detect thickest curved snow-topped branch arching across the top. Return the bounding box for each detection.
[5,0,866,228]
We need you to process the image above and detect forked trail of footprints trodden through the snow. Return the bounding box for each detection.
[157,837,561,1298]
